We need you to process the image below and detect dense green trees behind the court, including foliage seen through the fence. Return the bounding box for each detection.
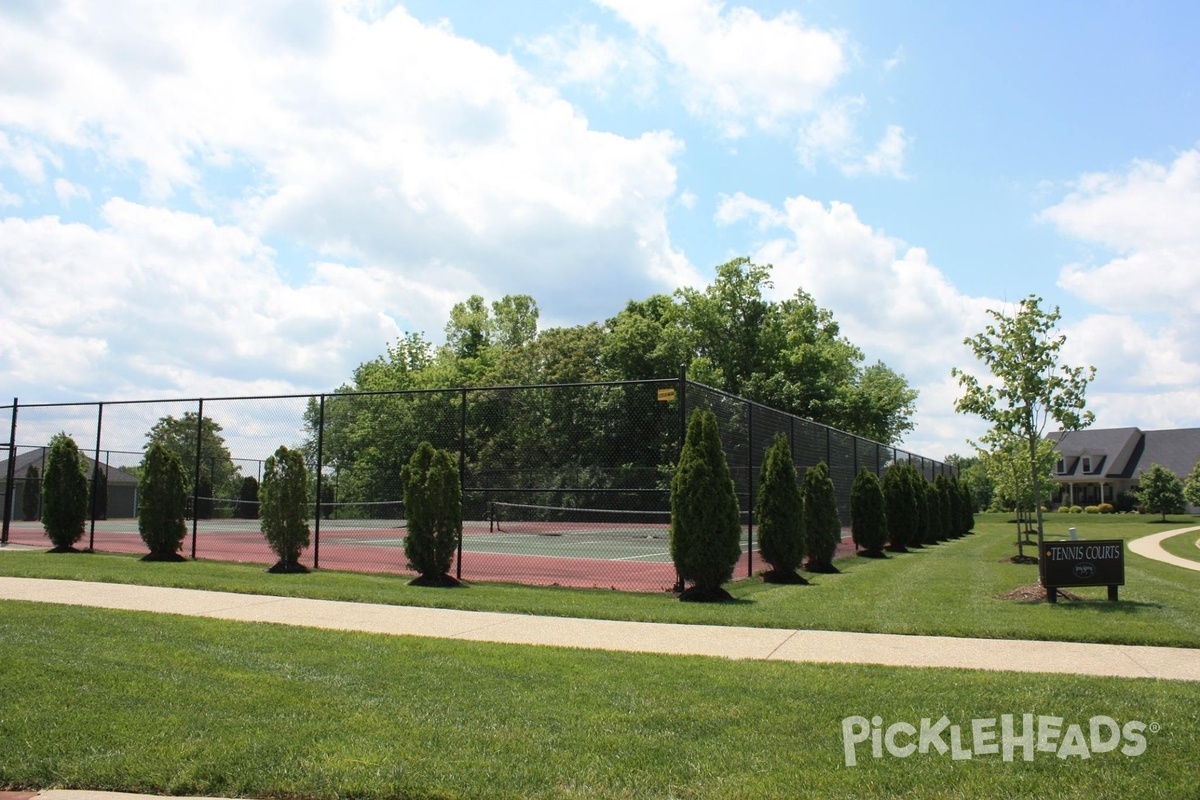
[309,258,917,513]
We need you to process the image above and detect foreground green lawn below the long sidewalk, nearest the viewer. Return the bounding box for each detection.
[0,602,1200,800]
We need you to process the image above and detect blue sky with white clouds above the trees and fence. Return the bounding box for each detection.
[0,0,1200,457]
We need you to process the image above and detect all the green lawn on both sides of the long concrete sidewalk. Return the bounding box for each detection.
[0,516,1200,800]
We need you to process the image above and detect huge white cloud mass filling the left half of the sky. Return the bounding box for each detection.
[0,0,698,398]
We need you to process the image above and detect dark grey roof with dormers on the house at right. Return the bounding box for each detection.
[1046,428,1200,480]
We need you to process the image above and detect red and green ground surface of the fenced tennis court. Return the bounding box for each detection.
[8,519,854,591]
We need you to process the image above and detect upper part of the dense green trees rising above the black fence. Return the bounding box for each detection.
[324,258,917,443]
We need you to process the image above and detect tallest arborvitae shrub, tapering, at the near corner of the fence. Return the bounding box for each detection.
[671,409,742,601]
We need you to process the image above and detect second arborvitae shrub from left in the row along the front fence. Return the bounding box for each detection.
[138,441,187,561]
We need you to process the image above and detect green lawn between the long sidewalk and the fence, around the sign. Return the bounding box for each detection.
[0,515,1200,646]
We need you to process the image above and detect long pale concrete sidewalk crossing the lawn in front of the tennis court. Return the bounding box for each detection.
[0,578,1200,681]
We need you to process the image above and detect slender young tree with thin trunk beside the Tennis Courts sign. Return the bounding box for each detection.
[950,295,1096,578]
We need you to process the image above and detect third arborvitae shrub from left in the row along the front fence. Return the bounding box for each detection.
[258,446,311,572]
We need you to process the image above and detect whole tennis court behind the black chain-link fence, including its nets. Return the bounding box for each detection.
[8,503,853,591]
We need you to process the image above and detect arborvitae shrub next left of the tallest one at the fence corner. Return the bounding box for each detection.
[402,441,462,587]
